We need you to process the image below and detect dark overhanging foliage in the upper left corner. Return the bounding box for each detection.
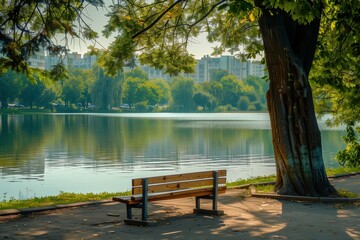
[0,0,104,81]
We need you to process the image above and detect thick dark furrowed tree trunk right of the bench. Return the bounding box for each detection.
[256,1,336,196]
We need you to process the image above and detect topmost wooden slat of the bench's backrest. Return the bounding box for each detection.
[132,170,226,186]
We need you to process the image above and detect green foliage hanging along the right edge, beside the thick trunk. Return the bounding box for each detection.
[311,0,360,166]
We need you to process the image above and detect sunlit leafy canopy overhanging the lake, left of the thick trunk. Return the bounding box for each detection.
[100,0,327,73]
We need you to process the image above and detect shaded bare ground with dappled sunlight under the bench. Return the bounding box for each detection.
[0,175,360,240]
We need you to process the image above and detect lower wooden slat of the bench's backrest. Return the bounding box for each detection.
[132,178,226,194]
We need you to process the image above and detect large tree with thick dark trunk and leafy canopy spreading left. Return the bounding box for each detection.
[100,0,352,196]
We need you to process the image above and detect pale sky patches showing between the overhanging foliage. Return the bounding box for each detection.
[69,2,225,59]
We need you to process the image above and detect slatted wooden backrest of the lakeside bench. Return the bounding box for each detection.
[132,170,226,195]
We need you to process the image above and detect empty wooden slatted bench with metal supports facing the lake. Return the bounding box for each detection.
[113,170,226,226]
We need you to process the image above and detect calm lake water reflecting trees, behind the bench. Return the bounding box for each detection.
[0,113,344,201]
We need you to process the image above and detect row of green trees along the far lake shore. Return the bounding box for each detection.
[0,66,268,112]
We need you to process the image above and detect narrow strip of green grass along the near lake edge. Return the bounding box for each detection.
[0,168,360,210]
